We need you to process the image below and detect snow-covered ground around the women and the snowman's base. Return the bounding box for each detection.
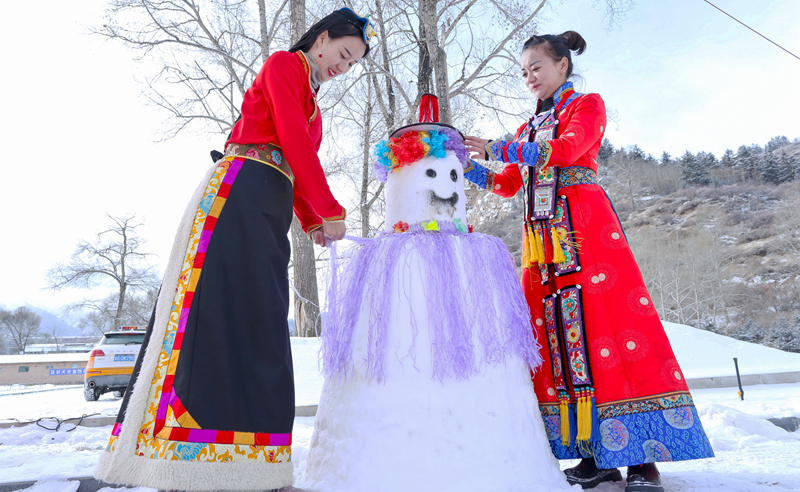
[0,324,800,492]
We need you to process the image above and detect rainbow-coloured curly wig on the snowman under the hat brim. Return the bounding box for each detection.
[375,127,469,182]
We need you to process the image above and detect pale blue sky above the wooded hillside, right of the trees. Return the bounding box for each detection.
[541,0,800,156]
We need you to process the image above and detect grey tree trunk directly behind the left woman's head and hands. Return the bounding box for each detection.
[289,0,321,337]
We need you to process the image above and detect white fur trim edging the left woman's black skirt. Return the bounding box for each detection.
[94,163,294,491]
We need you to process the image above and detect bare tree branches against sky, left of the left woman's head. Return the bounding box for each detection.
[93,0,289,138]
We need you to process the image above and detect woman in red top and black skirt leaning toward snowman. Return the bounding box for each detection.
[96,9,374,491]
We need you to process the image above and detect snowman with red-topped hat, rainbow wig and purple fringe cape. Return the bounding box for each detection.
[297,96,569,492]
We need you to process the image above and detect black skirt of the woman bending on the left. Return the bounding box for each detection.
[117,157,294,434]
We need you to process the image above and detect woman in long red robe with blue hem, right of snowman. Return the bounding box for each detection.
[464,31,713,492]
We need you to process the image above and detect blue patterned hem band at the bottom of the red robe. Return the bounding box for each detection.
[542,405,714,468]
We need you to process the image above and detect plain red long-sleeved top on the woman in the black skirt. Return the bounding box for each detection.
[225,51,346,232]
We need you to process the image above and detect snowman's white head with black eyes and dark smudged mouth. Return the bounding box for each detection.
[386,152,466,226]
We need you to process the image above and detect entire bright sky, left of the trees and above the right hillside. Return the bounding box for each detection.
[0,0,800,310]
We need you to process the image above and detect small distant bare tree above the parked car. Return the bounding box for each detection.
[47,215,158,326]
